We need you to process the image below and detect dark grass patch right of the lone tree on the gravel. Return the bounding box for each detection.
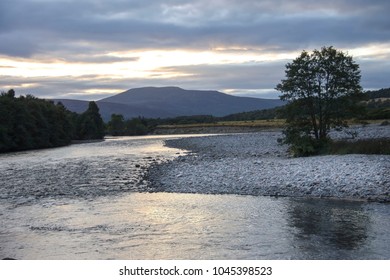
[326,138,390,155]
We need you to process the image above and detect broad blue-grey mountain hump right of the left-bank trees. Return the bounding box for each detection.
[98,87,283,118]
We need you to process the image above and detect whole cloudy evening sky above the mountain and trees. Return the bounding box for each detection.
[0,0,390,100]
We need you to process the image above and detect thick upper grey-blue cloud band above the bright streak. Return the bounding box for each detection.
[0,0,390,56]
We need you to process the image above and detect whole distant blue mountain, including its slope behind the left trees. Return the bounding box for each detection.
[56,87,284,121]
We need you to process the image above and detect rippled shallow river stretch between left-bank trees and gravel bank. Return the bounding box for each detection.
[0,136,193,201]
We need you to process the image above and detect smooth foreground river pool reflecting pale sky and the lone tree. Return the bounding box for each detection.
[0,193,390,259]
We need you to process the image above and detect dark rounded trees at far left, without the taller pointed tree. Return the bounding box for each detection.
[0,90,74,152]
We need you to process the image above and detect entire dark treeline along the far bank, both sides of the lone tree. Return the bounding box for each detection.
[0,88,390,152]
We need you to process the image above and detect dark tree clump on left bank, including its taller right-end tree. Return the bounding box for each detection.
[0,89,104,152]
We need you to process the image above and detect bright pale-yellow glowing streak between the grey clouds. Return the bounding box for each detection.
[0,48,295,81]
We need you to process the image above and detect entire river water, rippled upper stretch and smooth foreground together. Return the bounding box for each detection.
[0,136,390,260]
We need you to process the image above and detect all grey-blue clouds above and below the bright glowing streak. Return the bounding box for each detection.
[0,0,390,96]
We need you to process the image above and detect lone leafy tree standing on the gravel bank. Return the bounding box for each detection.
[276,47,363,155]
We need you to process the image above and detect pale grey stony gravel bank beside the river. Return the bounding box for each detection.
[147,125,390,202]
